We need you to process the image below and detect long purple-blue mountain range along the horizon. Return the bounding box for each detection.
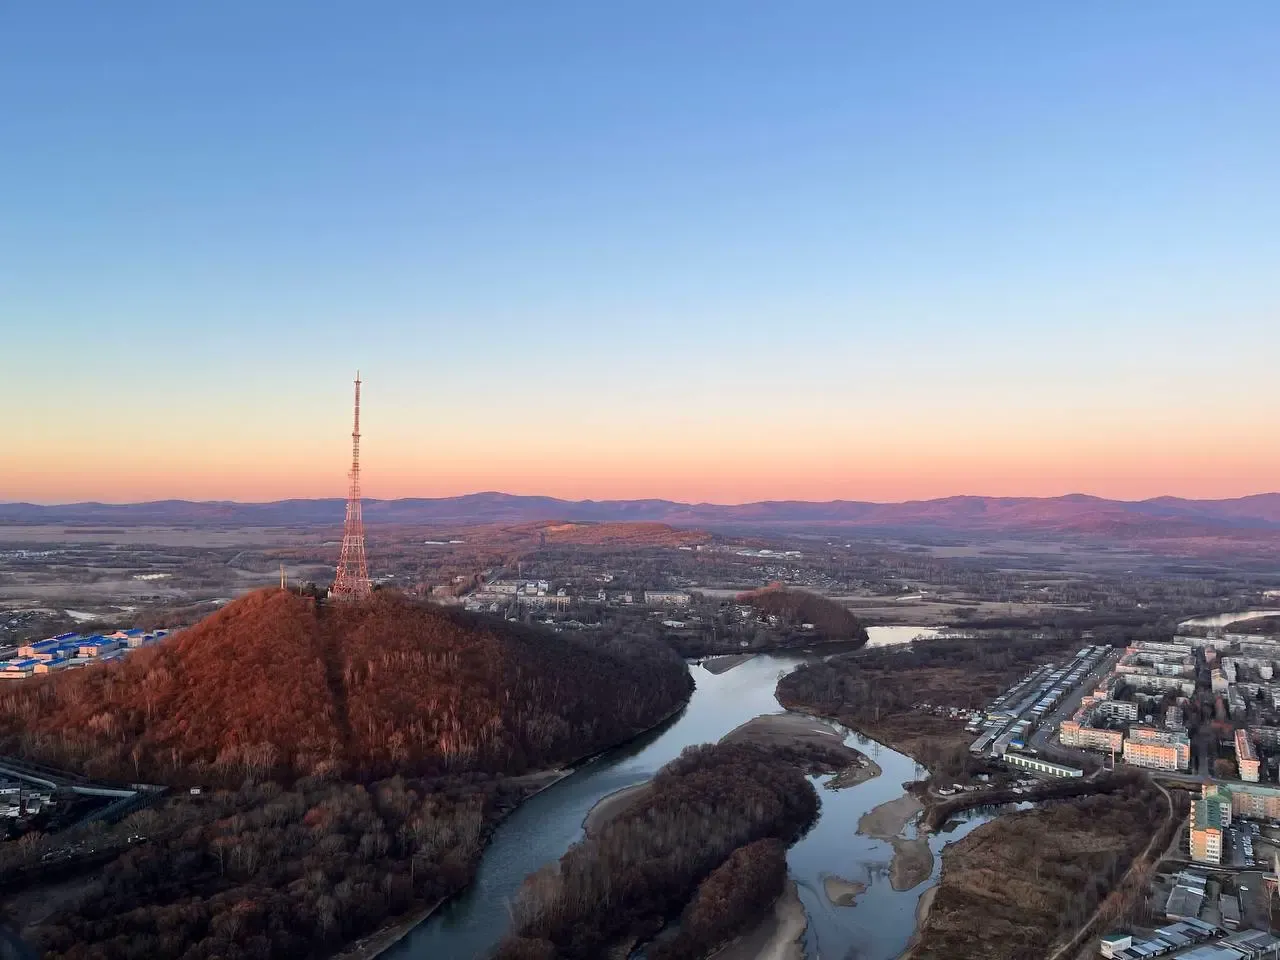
[0,493,1280,536]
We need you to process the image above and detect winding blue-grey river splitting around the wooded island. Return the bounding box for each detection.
[384,627,989,960]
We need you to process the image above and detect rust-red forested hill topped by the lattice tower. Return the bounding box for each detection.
[0,590,691,785]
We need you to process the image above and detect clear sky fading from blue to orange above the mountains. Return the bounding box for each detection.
[0,0,1280,502]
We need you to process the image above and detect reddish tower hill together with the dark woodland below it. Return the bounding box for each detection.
[0,590,701,960]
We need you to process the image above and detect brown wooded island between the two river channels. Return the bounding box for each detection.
[488,744,818,960]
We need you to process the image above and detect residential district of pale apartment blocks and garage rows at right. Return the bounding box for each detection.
[952,632,1280,960]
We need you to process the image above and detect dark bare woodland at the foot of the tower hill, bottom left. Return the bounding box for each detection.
[31,777,516,960]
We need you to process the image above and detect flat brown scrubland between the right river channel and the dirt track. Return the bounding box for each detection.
[910,778,1167,960]
